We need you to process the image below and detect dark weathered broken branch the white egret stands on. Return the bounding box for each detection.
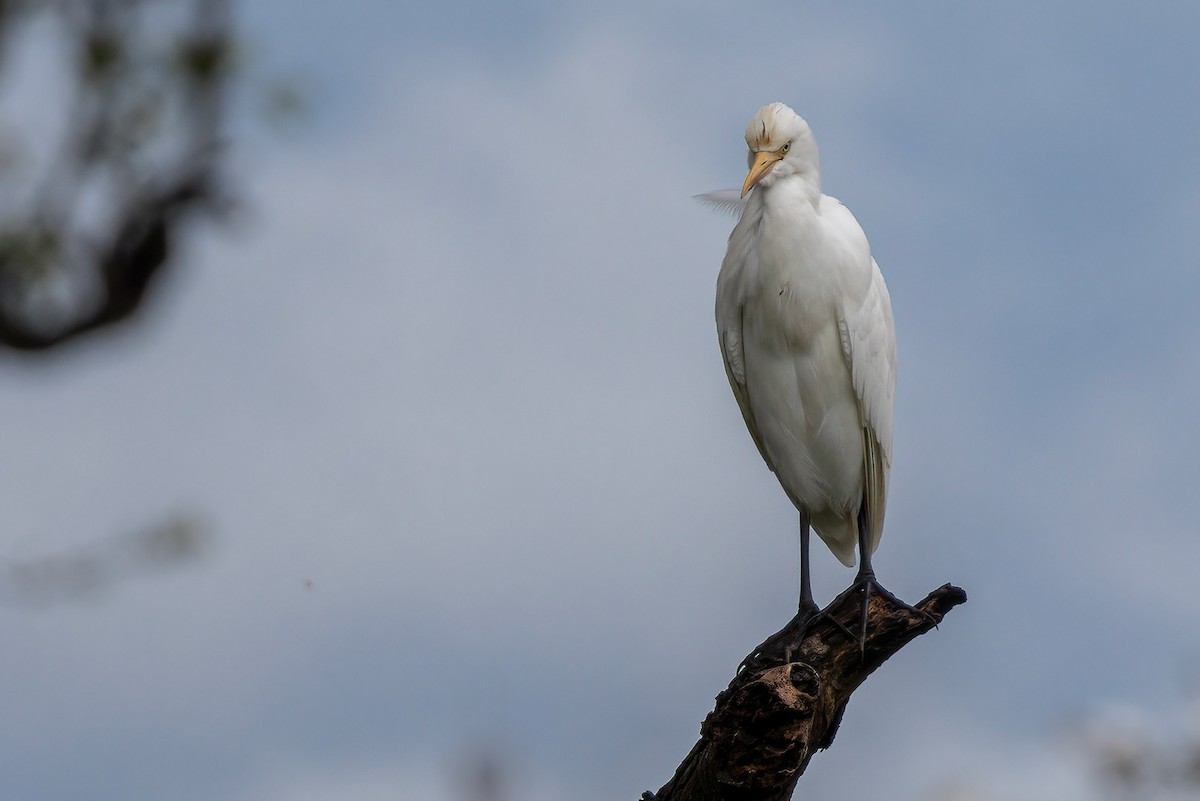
[643,584,966,801]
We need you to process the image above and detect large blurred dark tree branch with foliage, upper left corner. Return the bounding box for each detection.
[0,0,233,351]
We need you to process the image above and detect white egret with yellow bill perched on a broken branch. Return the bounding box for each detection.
[703,103,907,645]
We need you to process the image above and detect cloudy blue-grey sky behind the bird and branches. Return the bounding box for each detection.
[0,0,1200,801]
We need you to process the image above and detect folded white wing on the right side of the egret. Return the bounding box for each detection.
[839,259,896,552]
